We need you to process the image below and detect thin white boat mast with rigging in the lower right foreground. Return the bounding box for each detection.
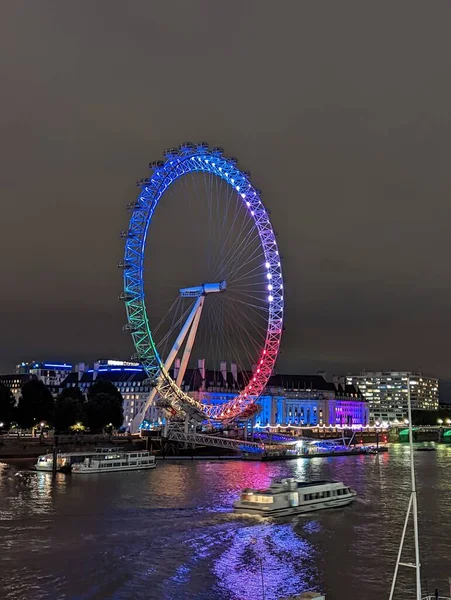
[389,379,421,600]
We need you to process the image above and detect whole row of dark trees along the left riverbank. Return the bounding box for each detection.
[0,379,124,433]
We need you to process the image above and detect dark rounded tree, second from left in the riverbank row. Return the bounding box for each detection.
[17,379,54,428]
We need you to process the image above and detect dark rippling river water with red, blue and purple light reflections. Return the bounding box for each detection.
[0,444,451,600]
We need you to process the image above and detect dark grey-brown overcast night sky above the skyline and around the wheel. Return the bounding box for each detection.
[0,0,451,394]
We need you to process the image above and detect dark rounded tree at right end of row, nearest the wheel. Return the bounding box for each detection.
[85,379,124,431]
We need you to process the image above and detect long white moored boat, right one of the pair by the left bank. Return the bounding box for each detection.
[72,451,157,475]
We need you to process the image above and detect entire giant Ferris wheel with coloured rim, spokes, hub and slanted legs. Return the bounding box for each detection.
[119,142,284,431]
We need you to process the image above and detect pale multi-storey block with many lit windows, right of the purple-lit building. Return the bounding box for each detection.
[346,371,439,424]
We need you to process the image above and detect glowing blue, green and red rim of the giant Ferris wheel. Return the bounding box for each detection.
[119,142,284,420]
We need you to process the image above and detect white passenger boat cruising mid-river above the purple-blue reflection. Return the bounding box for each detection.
[233,478,357,516]
